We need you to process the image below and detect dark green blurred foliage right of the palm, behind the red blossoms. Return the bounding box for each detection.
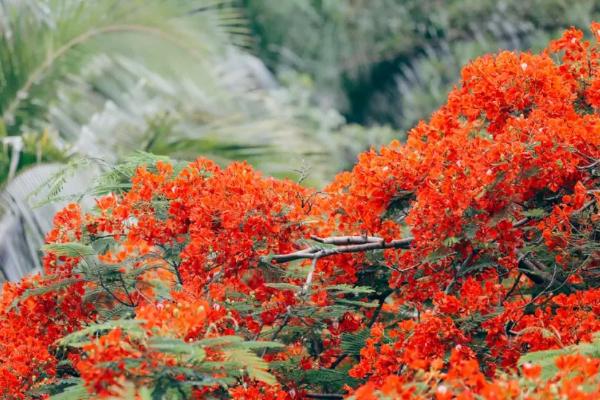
[240,0,600,131]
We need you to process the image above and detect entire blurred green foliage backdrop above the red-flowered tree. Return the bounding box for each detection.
[0,0,600,185]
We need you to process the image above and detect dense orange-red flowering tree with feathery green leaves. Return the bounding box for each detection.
[0,24,600,400]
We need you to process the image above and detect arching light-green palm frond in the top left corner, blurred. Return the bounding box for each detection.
[0,0,241,134]
